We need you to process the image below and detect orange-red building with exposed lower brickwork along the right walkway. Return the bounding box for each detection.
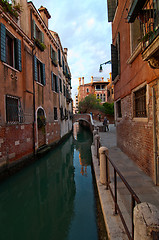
[108,0,159,184]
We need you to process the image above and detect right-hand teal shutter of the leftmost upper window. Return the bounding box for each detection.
[15,38,22,72]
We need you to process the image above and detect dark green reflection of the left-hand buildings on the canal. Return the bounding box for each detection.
[0,137,76,240]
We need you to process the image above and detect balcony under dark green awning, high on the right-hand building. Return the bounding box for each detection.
[128,0,159,69]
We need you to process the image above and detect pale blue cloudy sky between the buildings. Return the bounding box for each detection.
[32,0,112,100]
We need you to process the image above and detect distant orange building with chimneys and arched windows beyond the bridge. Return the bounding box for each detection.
[78,77,109,103]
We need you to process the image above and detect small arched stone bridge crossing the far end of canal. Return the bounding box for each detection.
[73,113,94,131]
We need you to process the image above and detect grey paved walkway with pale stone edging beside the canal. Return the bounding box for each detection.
[92,122,159,239]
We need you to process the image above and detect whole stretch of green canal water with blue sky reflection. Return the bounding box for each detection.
[0,125,98,240]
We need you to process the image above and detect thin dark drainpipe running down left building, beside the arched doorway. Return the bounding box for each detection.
[30,10,36,157]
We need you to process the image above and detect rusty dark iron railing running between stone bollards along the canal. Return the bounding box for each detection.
[97,139,141,240]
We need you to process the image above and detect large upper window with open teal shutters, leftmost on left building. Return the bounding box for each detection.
[0,23,22,71]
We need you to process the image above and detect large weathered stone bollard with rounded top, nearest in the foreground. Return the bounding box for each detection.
[134,202,159,240]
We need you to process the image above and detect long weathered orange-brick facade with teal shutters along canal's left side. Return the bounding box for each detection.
[0,0,72,169]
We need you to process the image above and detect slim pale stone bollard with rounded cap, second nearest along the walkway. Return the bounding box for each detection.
[99,147,108,185]
